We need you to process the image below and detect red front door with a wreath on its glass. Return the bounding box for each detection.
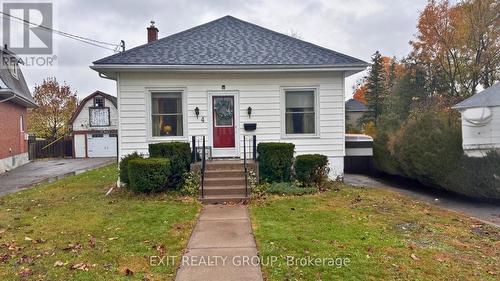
[212,96,235,148]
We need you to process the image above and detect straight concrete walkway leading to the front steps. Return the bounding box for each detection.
[176,205,263,281]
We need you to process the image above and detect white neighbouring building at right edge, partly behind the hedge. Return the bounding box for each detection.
[453,83,500,157]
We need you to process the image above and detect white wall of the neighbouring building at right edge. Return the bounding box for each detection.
[462,106,500,157]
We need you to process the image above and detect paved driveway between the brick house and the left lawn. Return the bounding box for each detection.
[0,157,116,196]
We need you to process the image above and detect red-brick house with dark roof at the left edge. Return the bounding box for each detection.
[0,48,36,173]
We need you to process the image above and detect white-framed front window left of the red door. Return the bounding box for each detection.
[151,92,184,137]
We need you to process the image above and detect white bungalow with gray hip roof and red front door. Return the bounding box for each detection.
[91,16,368,177]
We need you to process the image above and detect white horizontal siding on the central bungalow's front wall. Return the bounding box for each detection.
[118,72,345,176]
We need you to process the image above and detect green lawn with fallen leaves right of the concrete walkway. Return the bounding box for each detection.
[250,186,500,280]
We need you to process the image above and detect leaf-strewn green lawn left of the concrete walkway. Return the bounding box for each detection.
[0,165,200,280]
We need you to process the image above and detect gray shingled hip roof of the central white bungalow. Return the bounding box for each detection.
[94,16,368,67]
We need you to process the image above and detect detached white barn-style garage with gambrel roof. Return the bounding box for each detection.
[70,91,118,158]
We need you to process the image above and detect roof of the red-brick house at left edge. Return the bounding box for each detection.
[0,49,36,107]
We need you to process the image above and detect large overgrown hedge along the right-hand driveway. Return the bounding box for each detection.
[374,111,500,200]
